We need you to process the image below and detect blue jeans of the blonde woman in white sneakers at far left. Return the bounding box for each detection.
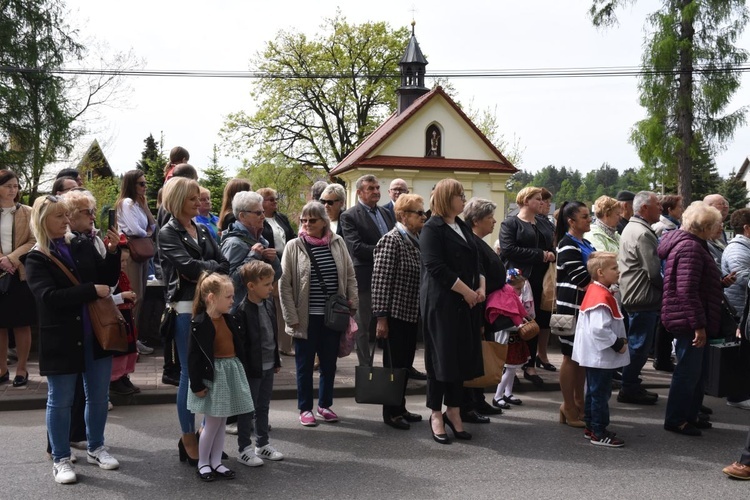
[47,333,112,462]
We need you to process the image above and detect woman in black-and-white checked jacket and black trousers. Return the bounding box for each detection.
[372,191,427,430]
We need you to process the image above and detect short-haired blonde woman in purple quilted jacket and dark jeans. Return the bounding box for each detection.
[658,201,722,436]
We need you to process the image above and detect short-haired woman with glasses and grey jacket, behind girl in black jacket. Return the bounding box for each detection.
[221,191,281,308]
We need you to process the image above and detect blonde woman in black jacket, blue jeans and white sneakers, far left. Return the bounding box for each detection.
[26,196,120,483]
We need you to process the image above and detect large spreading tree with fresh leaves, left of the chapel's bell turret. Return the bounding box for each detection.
[222,11,409,172]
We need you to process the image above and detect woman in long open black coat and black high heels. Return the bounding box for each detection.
[419,179,485,444]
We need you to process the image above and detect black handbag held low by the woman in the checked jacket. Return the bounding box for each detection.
[354,339,406,406]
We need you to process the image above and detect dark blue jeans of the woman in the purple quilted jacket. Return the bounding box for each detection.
[664,335,707,426]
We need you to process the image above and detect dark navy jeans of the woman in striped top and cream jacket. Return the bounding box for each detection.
[294,316,341,412]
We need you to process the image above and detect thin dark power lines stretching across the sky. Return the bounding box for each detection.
[0,65,750,80]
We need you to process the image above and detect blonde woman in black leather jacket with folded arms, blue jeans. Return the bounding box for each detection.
[158,177,229,465]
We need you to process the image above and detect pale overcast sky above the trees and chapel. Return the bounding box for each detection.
[61,0,750,180]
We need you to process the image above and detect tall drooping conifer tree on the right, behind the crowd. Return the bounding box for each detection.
[589,0,748,203]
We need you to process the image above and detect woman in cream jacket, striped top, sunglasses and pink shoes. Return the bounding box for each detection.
[279,201,359,427]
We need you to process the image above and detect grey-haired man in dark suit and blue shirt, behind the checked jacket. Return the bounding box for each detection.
[339,175,396,366]
